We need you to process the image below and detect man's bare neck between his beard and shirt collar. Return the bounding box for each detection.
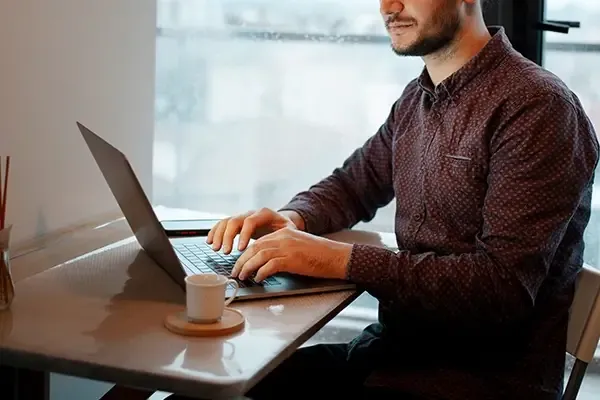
[423,21,491,86]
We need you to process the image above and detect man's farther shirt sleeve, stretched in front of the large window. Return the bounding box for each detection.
[279,102,397,235]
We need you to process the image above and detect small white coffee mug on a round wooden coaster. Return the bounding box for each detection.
[185,274,240,324]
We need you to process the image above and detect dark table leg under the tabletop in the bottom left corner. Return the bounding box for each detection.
[0,366,50,400]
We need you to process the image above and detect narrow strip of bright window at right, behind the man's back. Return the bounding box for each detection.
[543,0,600,268]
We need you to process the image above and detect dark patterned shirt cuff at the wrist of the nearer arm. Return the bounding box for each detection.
[346,244,395,289]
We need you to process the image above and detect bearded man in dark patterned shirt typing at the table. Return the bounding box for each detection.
[108,0,598,400]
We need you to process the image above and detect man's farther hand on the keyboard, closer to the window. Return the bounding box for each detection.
[206,208,304,254]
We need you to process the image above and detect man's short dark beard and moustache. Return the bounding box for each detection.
[386,1,461,57]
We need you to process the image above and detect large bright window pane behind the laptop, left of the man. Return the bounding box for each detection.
[153,0,423,231]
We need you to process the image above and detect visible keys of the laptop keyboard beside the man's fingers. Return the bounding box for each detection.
[173,243,280,287]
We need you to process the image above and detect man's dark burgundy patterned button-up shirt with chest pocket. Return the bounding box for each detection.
[283,28,598,400]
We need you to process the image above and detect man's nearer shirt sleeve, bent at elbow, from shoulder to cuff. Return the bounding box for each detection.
[347,95,598,323]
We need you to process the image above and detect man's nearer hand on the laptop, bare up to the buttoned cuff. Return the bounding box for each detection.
[231,228,352,282]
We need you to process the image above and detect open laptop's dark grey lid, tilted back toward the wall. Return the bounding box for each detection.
[77,122,185,287]
